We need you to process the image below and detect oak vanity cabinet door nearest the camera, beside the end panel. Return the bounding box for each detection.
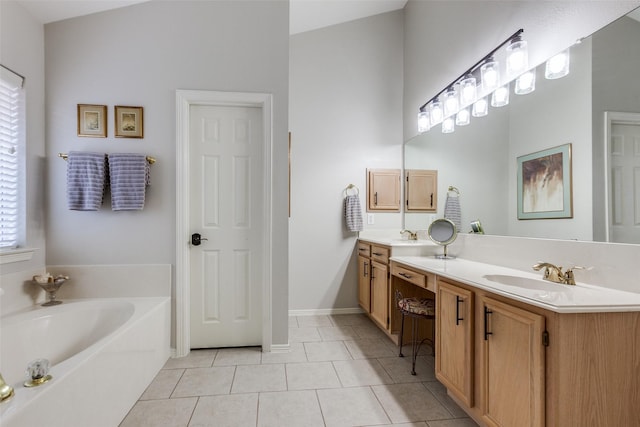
[480,297,545,427]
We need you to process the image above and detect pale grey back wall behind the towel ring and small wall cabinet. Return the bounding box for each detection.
[289,11,403,310]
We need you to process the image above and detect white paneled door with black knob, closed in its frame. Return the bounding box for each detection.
[189,105,264,348]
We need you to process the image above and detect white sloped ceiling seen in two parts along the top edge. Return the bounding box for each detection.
[17,0,407,34]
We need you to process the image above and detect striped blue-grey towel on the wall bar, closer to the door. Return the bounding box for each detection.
[109,153,149,211]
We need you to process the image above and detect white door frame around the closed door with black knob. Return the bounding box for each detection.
[175,90,273,357]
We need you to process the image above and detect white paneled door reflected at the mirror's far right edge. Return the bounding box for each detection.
[609,123,640,243]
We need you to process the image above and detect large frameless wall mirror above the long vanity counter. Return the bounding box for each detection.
[404,9,640,244]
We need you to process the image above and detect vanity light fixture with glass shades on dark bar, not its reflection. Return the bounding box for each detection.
[418,29,529,133]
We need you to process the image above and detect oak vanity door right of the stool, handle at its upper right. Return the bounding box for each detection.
[436,281,474,408]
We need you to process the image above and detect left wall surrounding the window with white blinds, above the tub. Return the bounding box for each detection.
[0,0,46,312]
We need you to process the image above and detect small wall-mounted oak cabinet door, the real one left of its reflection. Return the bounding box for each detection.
[367,169,400,212]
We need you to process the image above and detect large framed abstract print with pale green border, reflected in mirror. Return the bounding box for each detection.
[517,143,573,220]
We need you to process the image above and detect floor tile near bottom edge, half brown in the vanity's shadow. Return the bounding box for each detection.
[371,383,452,423]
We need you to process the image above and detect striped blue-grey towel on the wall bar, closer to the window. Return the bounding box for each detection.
[67,151,106,211]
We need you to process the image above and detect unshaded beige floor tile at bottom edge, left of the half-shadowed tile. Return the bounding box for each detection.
[316,387,390,427]
